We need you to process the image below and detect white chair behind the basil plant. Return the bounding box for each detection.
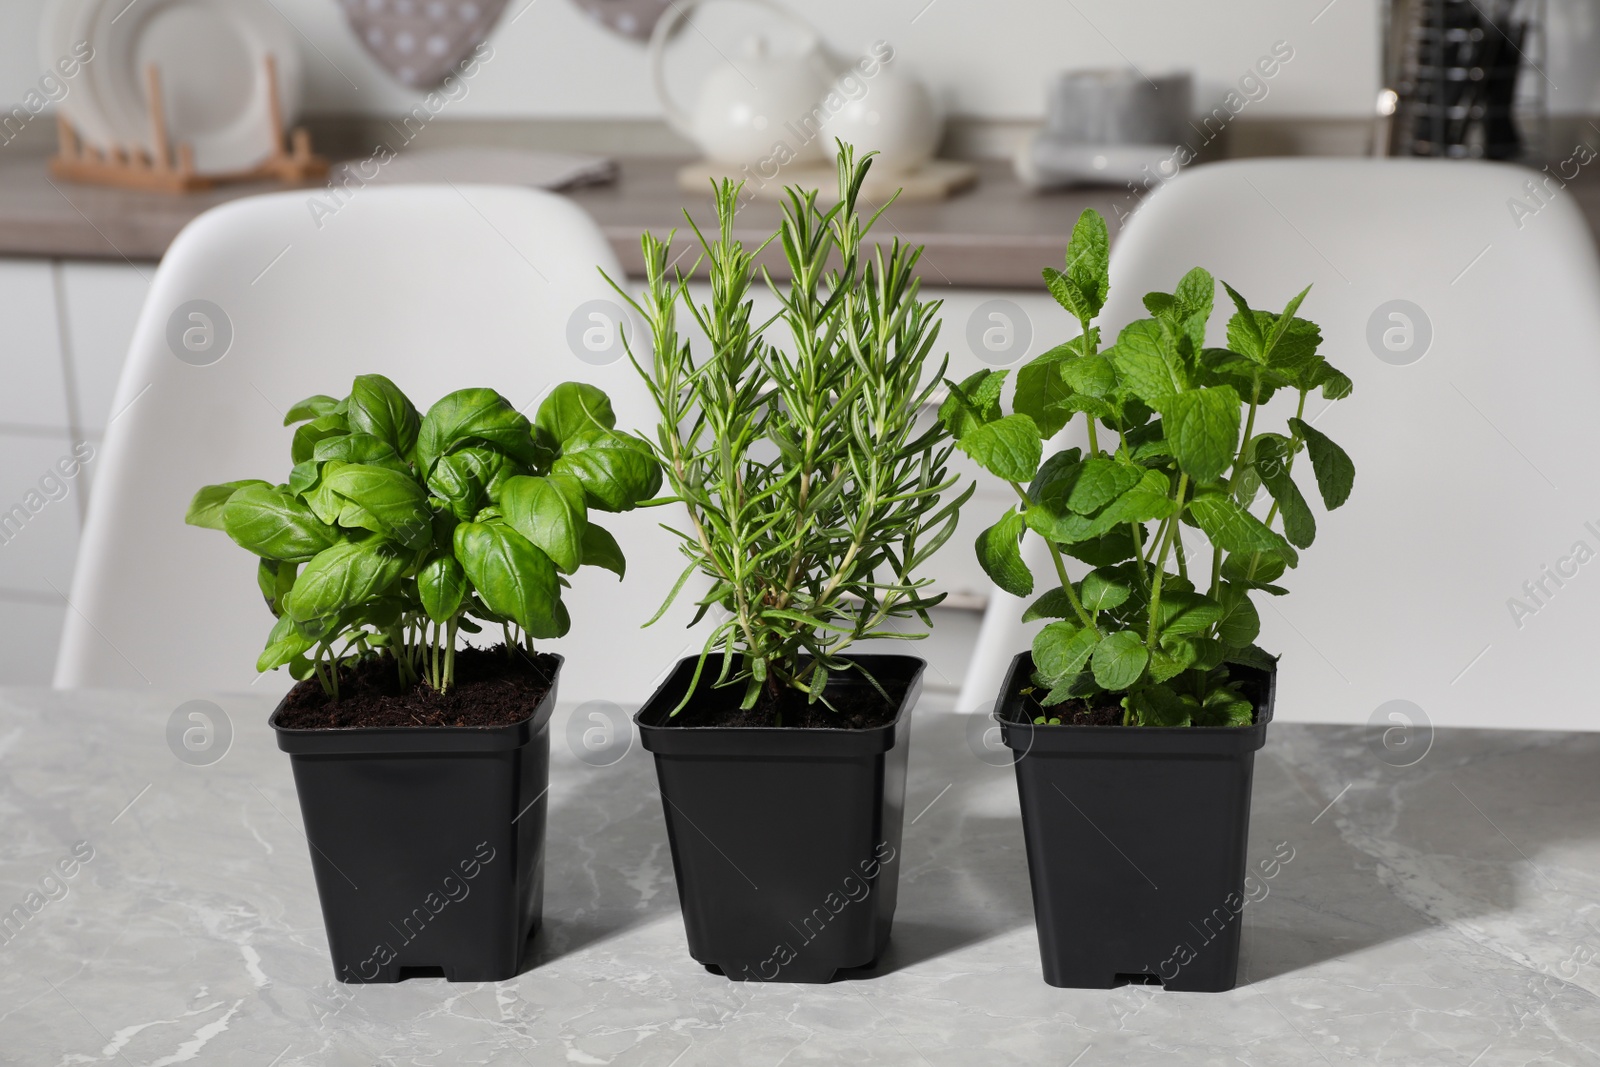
[56,186,698,704]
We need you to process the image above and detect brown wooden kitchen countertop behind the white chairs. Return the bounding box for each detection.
[0,152,1133,288]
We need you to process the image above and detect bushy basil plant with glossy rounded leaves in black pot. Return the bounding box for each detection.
[187,374,661,982]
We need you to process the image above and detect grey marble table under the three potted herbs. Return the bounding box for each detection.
[0,689,1600,1067]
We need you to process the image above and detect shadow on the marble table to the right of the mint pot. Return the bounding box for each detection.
[1238,726,1600,985]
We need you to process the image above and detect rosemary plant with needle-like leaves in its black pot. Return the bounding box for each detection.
[611,147,971,982]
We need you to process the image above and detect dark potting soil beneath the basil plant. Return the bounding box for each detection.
[278,646,557,729]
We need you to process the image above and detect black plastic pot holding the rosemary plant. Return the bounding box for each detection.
[634,656,923,982]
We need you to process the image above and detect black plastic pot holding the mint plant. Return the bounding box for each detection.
[995,653,1277,992]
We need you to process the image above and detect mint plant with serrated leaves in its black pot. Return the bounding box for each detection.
[941,211,1355,990]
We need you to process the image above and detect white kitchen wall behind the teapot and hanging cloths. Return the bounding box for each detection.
[9,0,1600,127]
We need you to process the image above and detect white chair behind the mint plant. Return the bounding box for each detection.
[960,160,1600,728]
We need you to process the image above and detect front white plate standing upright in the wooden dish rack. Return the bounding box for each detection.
[75,0,301,174]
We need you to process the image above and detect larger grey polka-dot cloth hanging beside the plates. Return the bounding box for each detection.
[341,0,507,90]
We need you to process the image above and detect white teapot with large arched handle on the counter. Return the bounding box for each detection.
[650,0,834,166]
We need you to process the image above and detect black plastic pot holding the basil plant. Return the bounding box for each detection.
[278,657,560,982]
